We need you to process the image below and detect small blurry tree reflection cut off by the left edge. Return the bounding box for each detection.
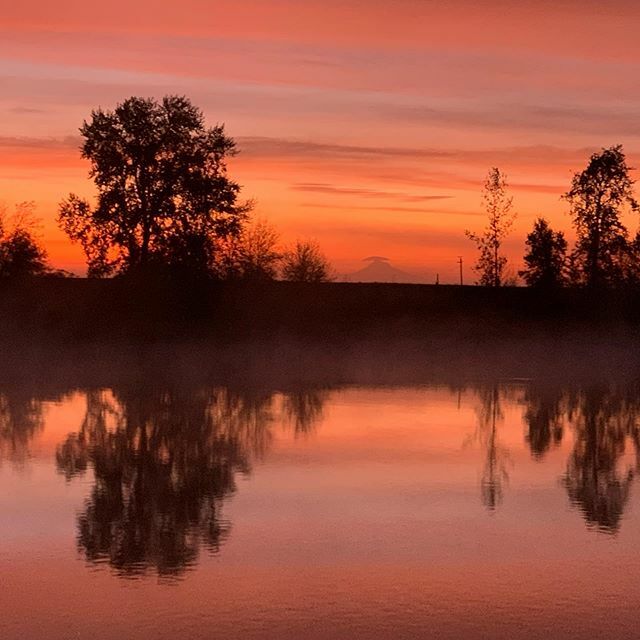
[0,386,43,464]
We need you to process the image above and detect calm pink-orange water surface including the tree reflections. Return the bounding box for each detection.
[0,380,640,640]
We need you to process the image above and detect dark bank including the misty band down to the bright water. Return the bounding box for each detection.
[0,279,640,388]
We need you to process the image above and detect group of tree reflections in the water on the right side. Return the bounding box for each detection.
[470,384,640,533]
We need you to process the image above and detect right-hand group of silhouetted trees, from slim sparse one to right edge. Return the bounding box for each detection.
[466,145,640,289]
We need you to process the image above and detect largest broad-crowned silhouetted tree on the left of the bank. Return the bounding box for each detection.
[58,96,250,276]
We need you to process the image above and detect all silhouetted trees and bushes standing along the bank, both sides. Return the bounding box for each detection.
[0,96,640,288]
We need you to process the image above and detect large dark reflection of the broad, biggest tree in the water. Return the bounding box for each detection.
[57,386,324,578]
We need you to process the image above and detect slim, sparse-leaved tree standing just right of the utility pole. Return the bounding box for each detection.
[465,167,516,287]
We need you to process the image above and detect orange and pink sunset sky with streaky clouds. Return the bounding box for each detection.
[0,0,640,282]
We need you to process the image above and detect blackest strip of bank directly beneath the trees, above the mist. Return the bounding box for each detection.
[0,278,640,343]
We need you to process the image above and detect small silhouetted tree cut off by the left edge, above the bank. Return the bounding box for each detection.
[0,202,51,278]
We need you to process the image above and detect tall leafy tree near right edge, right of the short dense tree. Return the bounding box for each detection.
[563,145,638,287]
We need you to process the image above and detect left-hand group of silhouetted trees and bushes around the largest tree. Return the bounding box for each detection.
[0,96,331,282]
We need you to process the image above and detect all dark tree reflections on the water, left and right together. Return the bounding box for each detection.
[0,382,640,579]
